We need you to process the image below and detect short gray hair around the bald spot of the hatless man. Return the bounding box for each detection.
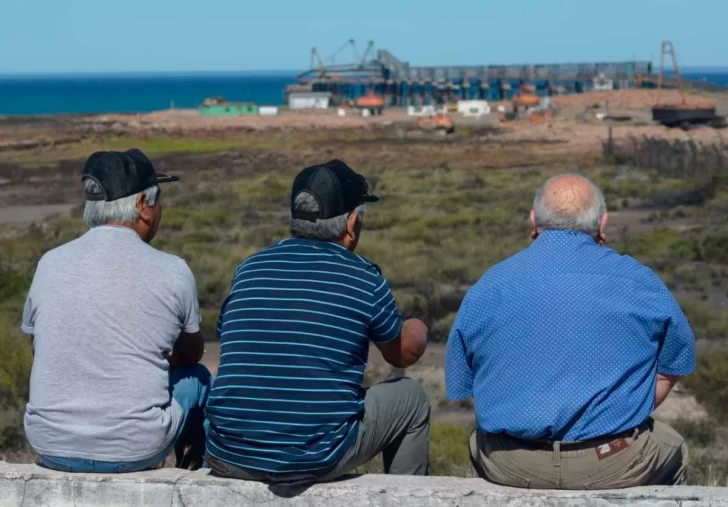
[533,174,607,234]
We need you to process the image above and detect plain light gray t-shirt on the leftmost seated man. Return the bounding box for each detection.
[22,226,201,461]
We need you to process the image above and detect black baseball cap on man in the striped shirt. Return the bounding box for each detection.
[291,160,379,222]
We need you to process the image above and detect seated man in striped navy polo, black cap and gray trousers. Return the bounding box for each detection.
[206,160,430,485]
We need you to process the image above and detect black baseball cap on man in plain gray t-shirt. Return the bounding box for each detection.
[81,148,179,202]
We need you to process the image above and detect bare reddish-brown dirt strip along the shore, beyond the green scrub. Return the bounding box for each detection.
[0,90,728,153]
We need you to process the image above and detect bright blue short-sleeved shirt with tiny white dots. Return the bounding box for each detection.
[445,230,695,441]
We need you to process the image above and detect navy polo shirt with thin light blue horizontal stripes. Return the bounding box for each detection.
[207,238,402,476]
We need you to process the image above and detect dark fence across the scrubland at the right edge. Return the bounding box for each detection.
[602,128,728,179]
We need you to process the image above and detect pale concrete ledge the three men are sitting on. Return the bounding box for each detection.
[0,462,728,507]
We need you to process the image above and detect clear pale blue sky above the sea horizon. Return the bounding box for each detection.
[0,0,728,74]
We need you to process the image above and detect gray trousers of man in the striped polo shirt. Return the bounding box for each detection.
[205,378,430,482]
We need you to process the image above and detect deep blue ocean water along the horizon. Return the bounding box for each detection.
[0,68,728,115]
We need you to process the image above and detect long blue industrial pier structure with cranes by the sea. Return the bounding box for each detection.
[286,40,653,106]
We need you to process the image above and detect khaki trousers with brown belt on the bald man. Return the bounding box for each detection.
[470,419,688,489]
